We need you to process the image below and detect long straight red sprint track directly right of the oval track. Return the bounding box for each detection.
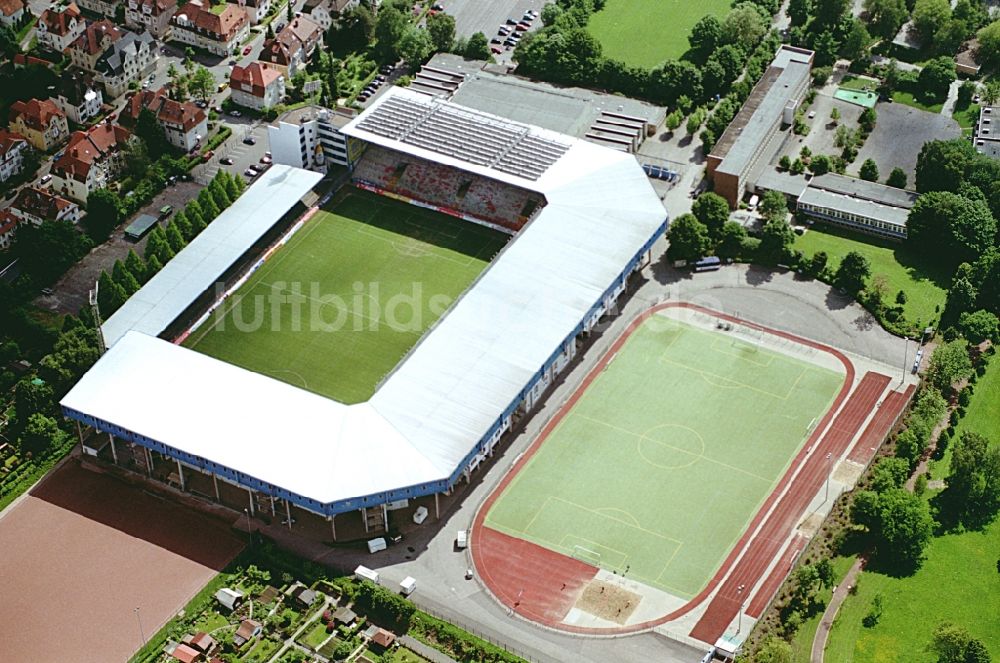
[691,372,889,642]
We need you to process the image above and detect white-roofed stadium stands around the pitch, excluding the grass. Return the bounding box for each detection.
[61,88,667,540]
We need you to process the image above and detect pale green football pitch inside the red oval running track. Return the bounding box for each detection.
[486,315,843,599]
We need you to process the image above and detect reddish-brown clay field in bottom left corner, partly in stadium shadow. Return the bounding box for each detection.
[0,461,243,663]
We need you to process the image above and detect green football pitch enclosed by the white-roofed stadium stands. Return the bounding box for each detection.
[184,191,509,403]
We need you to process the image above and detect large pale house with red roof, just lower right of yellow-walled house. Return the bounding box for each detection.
[52,122,132,202]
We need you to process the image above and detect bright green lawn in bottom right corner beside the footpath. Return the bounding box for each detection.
[824,506,1000,663]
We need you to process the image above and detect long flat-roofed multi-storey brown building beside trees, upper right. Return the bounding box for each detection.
[707,45,813,208]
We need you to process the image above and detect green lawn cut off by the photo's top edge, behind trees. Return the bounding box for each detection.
[587,0,730,68]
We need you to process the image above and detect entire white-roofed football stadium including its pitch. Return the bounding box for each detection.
[61,89,667,540]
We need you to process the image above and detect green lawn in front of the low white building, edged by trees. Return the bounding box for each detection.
[795,224,950,325]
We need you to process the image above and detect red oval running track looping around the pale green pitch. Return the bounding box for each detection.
[471,302,864,642]
